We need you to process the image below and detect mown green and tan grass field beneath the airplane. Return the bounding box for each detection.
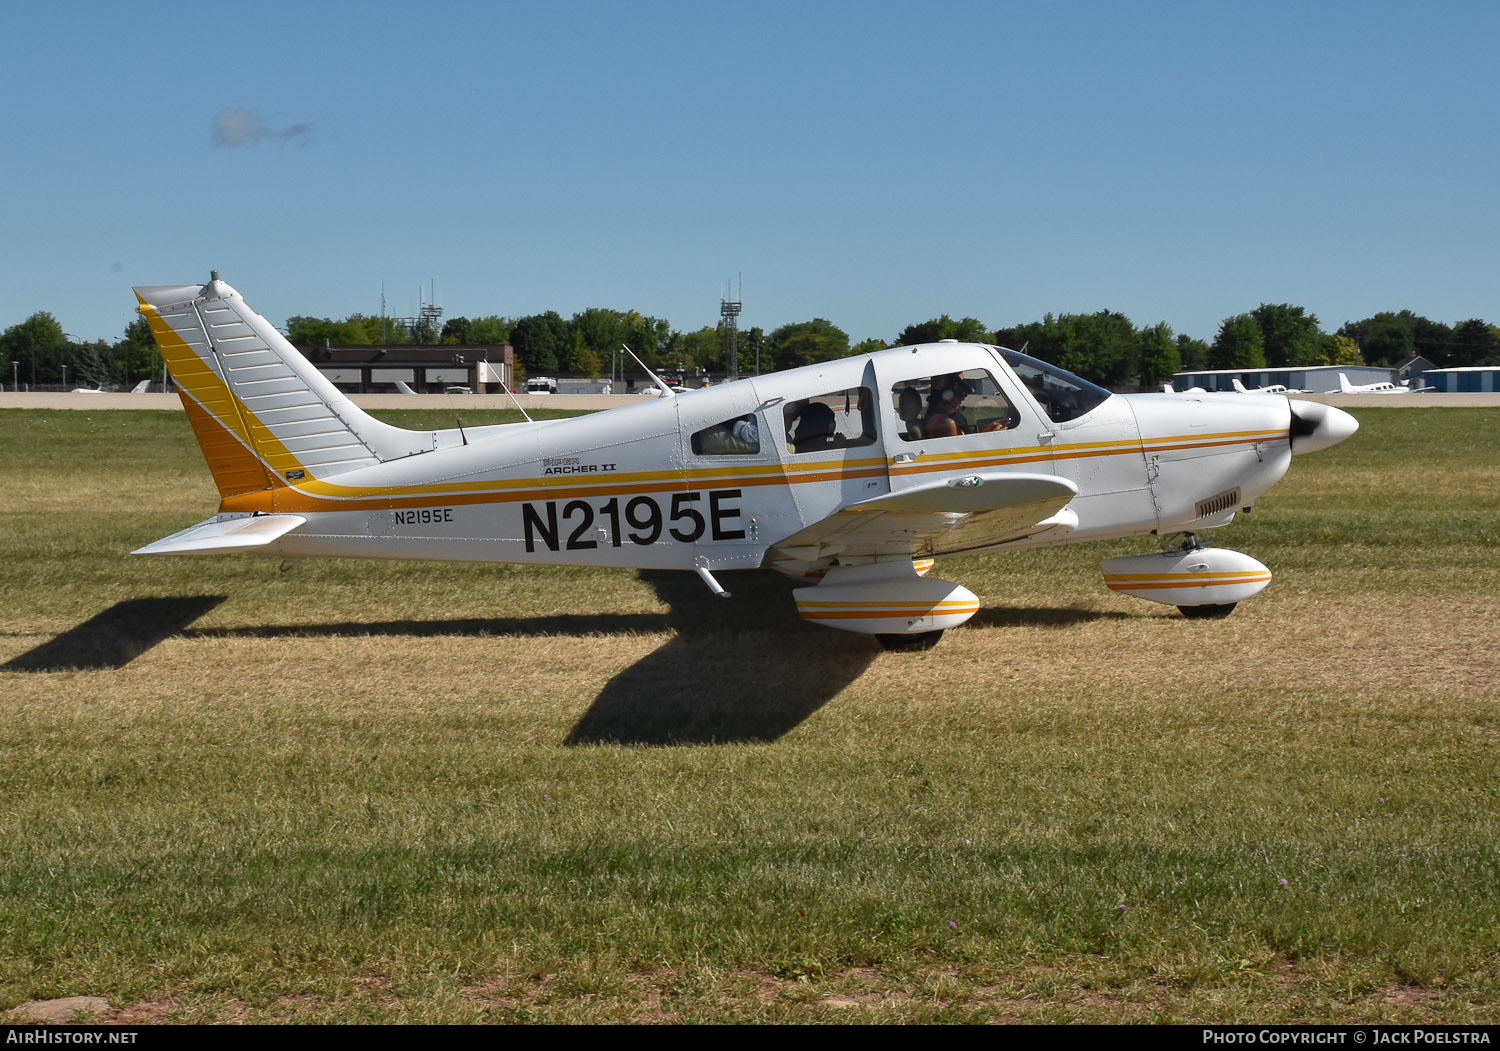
[0,409,1500,1023]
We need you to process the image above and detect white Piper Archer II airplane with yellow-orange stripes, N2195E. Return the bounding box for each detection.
[135,273,1358,649]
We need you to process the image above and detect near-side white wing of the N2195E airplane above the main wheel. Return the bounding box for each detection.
[770,471,1079,562]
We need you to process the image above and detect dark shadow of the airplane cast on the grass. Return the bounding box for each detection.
[3,571,1130,745]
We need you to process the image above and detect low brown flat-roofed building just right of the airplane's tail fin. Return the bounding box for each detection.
[297,343,516,394]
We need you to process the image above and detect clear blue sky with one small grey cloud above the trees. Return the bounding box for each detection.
[0,0,1500,340]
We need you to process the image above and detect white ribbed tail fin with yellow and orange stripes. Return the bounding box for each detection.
[135,271,434,499]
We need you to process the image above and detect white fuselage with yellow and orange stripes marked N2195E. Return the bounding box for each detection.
[208,343,1290,570]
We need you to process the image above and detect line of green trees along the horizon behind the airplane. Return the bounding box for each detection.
[0,303,1500,390]
